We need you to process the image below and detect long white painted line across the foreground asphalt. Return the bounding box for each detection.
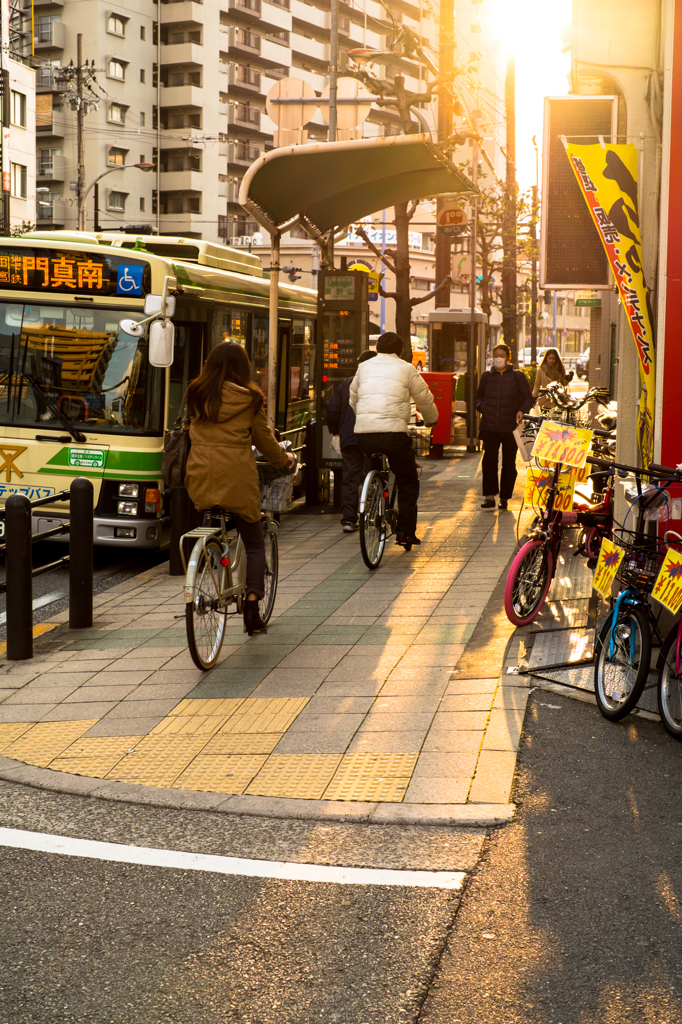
[0,828,465,889]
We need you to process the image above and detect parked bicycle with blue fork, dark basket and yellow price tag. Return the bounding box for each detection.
[594,460,682,727]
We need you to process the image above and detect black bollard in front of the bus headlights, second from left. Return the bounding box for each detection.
[69,476,94,630]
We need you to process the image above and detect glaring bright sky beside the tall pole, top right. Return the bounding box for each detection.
[486,0,571,190]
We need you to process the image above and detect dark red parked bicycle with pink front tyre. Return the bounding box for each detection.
[505,416,613,626]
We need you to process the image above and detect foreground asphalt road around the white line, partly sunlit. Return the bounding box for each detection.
[0,690,682,1024]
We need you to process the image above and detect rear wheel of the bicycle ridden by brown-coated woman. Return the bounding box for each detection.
[185,540,227,669]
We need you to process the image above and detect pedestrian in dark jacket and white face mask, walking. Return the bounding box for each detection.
[476,345,534,511]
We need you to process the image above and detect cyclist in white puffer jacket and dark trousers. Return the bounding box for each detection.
[349,332,438,550]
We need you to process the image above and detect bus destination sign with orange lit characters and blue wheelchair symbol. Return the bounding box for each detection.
[0,246,152,298]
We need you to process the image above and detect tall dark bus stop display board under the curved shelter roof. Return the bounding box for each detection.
[316,270,370,470]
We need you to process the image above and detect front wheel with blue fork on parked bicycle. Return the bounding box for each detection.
[594,604,651,722]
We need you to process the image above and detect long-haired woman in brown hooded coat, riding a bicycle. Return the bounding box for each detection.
[184,341,294,636]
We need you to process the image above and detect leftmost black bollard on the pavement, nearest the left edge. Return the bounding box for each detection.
[5,495,33,662]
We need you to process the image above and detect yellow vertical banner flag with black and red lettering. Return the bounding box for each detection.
[563,139,655,467]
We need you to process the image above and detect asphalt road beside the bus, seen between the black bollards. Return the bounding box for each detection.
[0,541,168,643]
